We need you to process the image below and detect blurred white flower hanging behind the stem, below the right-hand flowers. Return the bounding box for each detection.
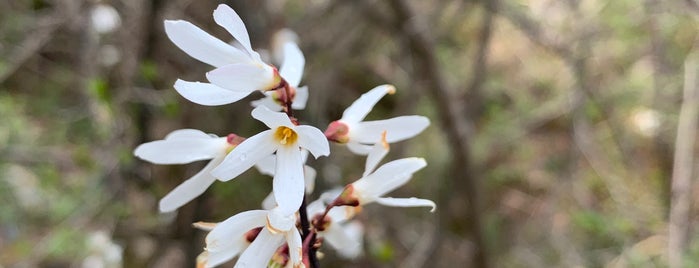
[308,193,364,259]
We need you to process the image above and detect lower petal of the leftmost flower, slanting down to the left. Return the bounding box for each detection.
[160,155,223,212]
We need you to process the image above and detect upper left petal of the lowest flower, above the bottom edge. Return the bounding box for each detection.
[206,210,267,255]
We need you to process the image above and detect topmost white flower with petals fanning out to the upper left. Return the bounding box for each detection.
[165,4,303,105]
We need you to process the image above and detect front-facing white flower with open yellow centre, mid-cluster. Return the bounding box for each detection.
[211,106,330,214]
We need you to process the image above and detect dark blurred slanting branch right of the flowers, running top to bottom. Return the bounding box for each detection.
[380,0,489,267]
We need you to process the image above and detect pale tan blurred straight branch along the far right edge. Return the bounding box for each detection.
[668,44,699,267]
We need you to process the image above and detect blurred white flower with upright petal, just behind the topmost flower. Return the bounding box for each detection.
[252,41,308,111]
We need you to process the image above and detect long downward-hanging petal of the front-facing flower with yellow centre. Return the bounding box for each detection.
[272,146,305,215]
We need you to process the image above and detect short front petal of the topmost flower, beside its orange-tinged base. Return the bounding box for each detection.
[206,63,276,92]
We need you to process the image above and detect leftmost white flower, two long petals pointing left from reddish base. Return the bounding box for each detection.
[134,129,243,212]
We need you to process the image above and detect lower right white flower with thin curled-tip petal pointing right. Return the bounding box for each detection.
[338,138,437,218]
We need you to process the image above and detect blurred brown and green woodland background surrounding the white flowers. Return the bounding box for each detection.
[0,0,699,267]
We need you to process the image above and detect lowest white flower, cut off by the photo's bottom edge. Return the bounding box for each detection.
[201,208,303,267]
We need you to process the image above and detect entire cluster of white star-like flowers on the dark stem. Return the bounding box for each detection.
[134,5,435,267]
